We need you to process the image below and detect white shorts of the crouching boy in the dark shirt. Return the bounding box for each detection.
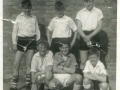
[54,74,71,87]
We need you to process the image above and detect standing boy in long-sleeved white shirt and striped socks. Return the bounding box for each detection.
[10,0,40,90]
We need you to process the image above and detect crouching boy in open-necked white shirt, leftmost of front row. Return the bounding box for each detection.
[31,41,53,90]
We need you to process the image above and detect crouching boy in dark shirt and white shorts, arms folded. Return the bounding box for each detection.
[49,42,82,90]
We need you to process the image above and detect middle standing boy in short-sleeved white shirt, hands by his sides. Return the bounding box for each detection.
[47,1,77,54]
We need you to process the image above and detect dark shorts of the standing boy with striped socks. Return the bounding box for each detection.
[17,36,37,52]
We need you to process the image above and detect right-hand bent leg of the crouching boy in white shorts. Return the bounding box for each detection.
[66,74,82,90]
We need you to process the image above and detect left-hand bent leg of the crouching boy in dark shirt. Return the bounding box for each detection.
[49,78,63,90]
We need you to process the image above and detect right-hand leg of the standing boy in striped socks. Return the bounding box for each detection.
[26,50,34,86]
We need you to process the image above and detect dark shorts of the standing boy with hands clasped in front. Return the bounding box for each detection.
[79,30,100,50]
